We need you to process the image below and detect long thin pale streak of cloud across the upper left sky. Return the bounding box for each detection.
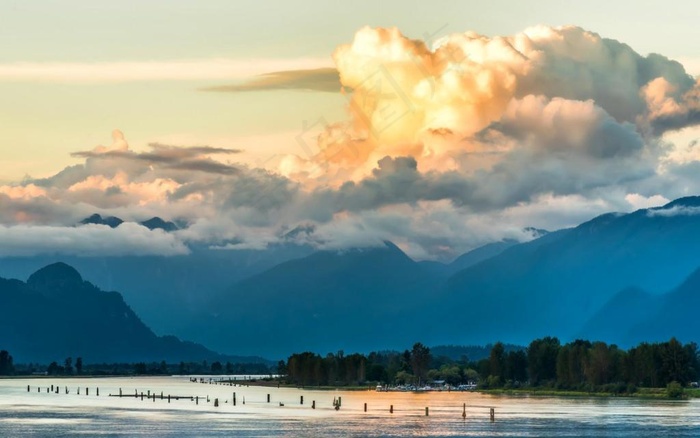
[0,58,331,82]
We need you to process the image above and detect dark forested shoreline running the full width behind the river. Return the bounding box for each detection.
[0,337,700,400]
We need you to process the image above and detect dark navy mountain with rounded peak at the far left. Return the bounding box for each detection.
[0,263,260,363]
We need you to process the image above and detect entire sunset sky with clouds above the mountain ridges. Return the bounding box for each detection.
[0,0,700,261]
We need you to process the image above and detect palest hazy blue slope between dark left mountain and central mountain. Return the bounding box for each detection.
[0,245,313,338]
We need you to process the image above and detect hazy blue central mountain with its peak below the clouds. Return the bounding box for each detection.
[196,242,437,357]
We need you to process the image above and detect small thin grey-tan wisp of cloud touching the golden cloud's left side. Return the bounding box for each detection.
[202,68,341,92]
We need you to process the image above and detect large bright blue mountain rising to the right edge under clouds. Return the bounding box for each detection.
[438,197,700,344]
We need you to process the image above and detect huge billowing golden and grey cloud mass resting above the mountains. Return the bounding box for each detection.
[0,26,700,260]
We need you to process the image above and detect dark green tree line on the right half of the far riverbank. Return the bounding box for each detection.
[278,337,700,393]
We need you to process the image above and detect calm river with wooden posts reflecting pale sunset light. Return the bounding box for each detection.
[0,376,700,438]
